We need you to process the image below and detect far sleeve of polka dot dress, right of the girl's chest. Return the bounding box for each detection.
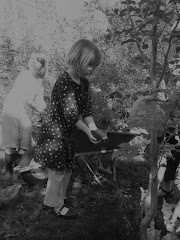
[81,82,92,118]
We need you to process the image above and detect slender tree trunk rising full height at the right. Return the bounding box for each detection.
[140,1,160,237]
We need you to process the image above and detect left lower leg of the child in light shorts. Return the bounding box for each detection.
[4,147,16,180]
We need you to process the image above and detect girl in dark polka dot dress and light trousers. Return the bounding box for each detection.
[34,39,102,218]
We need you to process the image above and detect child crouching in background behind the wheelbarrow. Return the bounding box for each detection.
[95,91,126,131]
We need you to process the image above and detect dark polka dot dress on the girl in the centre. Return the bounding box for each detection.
[34,72,92,171]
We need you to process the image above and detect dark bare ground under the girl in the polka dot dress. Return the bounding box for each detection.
[0,157,148,240]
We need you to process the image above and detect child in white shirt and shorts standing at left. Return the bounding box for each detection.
[2,52,47,180]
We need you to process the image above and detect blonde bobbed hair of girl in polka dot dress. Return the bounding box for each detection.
[66,39,102,74]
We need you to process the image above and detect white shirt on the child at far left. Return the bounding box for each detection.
[3,70,42,118]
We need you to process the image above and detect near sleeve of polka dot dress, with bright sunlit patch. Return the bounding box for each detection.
[52,78,79,125]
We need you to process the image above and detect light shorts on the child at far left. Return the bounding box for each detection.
[2,113,32,149]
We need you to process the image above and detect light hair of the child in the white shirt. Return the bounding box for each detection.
[28,52,48,78]
